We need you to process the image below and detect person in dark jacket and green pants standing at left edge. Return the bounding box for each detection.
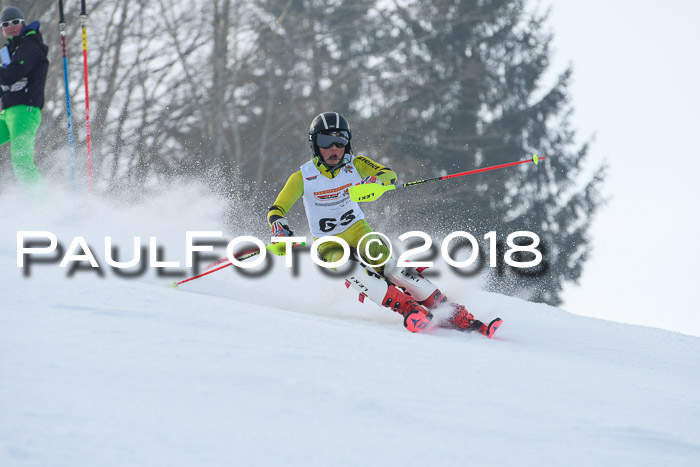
[0,6,49,189]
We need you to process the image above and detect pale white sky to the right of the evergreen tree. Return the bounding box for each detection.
[541,0,700,336]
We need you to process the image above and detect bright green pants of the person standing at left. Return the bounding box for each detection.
[0,105,42,189]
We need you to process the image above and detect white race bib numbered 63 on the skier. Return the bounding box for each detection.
[301,154,365,238]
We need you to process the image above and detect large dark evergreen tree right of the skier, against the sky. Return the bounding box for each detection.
[358,0,604,305]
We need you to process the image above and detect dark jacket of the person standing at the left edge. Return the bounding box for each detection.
[0,21,49,109]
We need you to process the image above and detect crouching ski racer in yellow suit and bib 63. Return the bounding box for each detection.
[267,112,500,337]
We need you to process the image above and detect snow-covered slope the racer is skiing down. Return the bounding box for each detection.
[0,187,700,466]
